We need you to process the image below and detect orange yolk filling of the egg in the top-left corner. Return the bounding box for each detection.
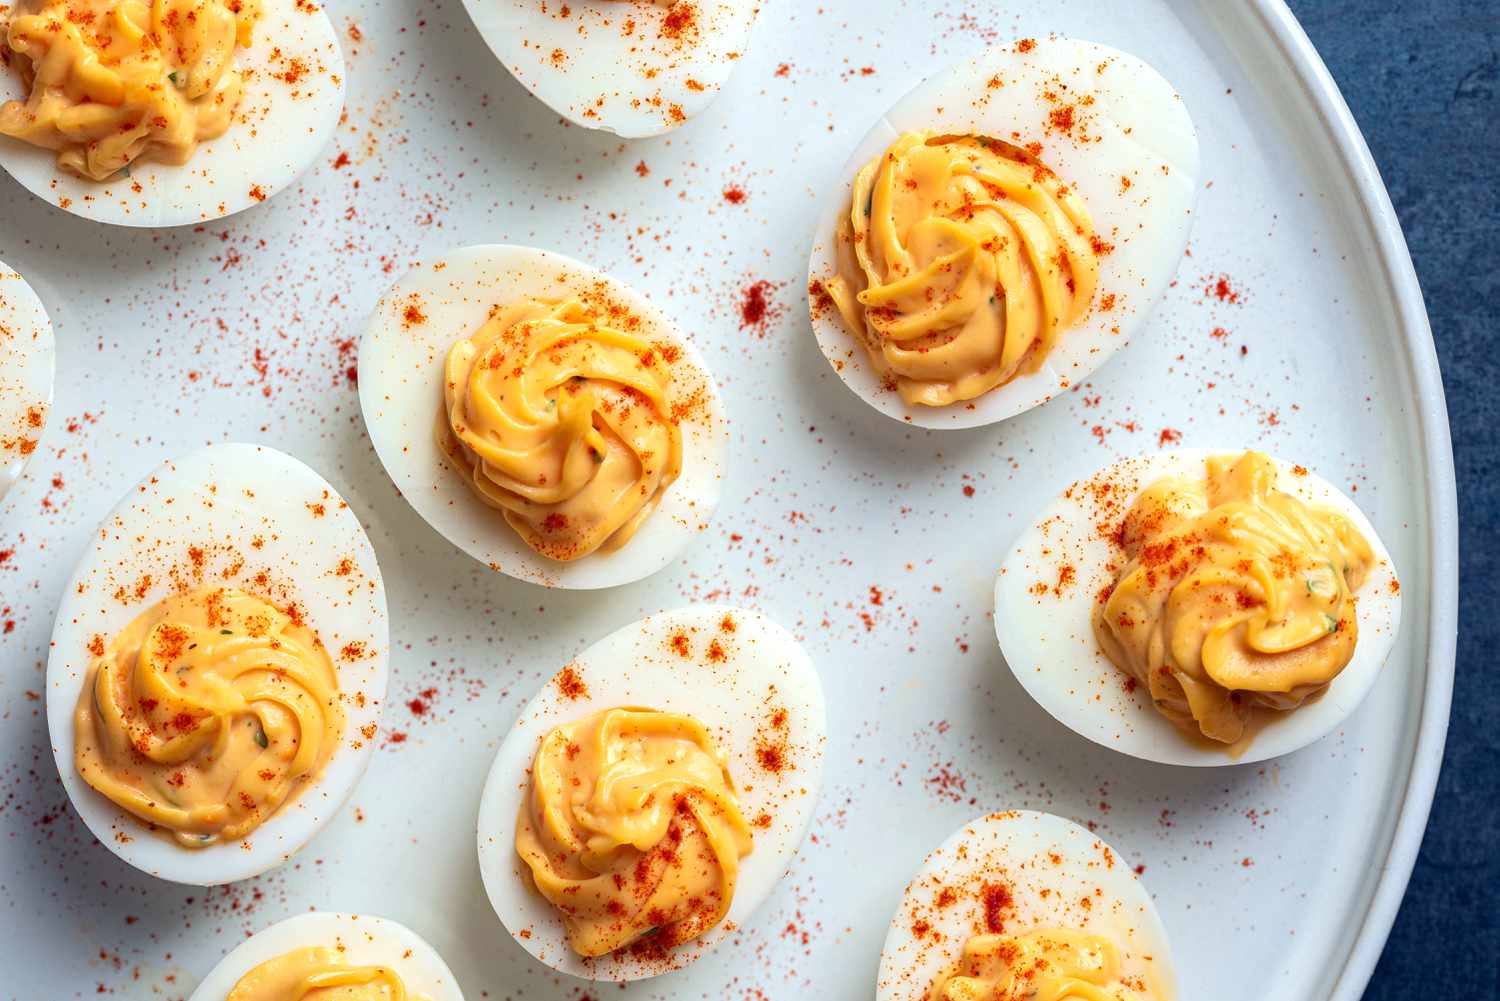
[0,0,260,182]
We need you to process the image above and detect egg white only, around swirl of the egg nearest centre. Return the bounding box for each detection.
[359,246,729,588]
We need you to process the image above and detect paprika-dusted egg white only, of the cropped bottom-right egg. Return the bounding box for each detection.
[875,810,1178,1001]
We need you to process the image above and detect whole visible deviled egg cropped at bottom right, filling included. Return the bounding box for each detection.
[875,810,1178,1001]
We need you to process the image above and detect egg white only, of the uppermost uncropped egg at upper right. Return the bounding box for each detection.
[807,38,1199,428]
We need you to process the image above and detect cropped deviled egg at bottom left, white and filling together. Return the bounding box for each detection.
[188,911,464,1001]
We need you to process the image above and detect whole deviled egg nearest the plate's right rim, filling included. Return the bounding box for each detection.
[995,449,1401,765]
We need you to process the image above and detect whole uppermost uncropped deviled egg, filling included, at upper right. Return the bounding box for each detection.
[807,38,1199,428]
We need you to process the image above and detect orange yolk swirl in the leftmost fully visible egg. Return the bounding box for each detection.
[74,588,344,848]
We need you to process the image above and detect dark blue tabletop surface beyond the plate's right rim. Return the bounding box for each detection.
[1290,0,1500,1001]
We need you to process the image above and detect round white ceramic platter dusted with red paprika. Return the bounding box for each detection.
[0,0,1457,1001]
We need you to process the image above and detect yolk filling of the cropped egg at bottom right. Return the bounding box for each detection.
[927,929,1149,1001]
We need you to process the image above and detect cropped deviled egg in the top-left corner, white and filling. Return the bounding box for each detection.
[0,0,345,227]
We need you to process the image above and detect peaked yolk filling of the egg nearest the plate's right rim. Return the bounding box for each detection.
[1094,452,1374,743]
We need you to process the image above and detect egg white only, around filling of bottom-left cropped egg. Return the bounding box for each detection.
[188,911,464,1001]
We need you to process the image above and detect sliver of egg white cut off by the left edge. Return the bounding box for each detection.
[0,261,57,498]
